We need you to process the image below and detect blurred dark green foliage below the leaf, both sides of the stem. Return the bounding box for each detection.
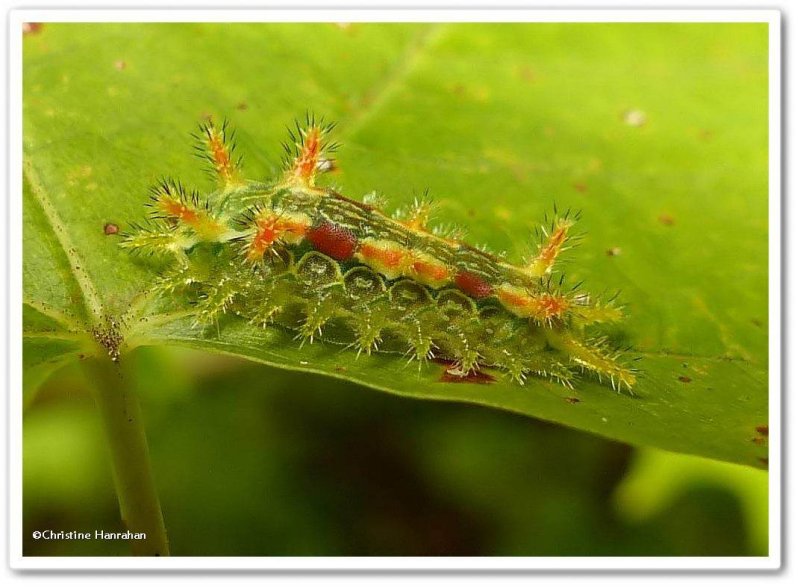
[24,348,767,556]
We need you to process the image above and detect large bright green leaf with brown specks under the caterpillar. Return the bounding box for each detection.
[23,23,768,467]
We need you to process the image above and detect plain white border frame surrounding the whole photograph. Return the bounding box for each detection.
[7,8,784,571]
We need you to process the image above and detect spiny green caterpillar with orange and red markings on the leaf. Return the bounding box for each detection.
[121,115,636,391]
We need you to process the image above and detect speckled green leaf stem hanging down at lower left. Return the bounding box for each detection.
[83,357,169,556]
